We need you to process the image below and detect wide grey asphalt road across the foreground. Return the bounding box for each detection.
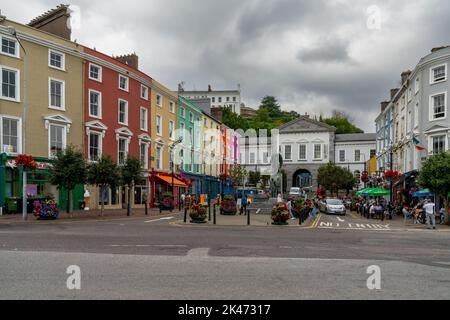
[0,215,450,300]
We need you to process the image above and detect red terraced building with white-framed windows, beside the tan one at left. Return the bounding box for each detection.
[84,48,152,208]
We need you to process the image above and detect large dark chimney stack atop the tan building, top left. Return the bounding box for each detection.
[28,4,72,41]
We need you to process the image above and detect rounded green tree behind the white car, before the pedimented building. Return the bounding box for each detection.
[317,162,356,194]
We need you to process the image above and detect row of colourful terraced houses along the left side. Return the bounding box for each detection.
[0,5,240,212]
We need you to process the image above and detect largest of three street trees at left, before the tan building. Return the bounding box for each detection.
[49,145,87,213]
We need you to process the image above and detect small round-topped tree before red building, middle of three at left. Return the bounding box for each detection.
[87,155,120,216]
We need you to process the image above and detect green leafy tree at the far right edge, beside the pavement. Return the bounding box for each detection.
[418,152,450,223]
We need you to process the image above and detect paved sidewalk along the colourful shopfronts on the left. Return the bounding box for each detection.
[0,208,180,224]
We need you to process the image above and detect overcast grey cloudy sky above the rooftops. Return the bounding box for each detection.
[0,0,450,132]
